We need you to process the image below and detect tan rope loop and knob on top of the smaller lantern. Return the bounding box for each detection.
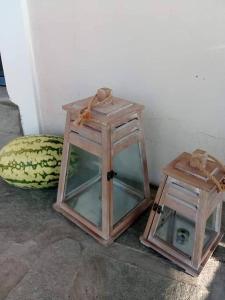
[190,150,225,192]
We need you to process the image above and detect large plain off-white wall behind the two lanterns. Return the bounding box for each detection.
[28,0,225,183]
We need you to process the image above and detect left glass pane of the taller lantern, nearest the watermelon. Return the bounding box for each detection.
[65,145,102,227]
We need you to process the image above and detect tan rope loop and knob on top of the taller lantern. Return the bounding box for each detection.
[74,88,112,125]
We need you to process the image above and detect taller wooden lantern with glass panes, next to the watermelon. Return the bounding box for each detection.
[54,93,150,244]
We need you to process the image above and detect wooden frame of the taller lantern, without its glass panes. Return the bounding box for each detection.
[54,97,151,245]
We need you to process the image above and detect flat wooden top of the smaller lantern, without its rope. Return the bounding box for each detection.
[164,152,225,192]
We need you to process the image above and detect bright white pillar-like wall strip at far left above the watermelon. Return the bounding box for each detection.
[0,0,39,134]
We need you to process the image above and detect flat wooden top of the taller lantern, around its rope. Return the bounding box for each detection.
[63,97,144,125]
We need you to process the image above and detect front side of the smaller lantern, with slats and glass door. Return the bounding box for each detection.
[144,178,198,265]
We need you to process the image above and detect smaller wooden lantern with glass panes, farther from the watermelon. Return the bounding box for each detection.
[140,150,225,276]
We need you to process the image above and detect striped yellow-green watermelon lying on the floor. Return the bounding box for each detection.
[0,135,66,189]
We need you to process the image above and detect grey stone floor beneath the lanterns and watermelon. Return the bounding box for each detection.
[0,177,225,300]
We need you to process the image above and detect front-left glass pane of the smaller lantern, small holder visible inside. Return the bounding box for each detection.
[155,206,195,257]
